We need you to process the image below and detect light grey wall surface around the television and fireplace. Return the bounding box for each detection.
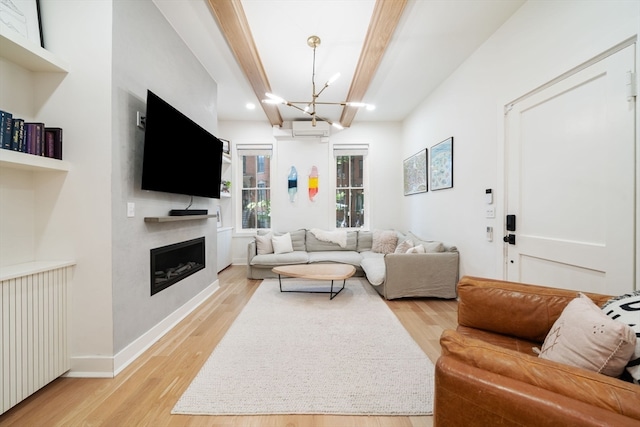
[111,0,222,362]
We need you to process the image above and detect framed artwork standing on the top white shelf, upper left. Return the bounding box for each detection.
[0,0,44,47]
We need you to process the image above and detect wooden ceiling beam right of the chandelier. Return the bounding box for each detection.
[340,0,407,127]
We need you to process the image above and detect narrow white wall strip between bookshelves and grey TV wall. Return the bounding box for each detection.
[37,1,113,370]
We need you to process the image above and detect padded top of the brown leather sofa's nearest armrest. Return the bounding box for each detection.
[440,330,640,420]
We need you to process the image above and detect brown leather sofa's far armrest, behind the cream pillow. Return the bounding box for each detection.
[458,276,611,342]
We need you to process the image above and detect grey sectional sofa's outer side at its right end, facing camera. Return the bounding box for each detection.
[384,251,459,299]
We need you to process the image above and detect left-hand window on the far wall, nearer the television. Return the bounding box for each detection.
[238,145,272,230]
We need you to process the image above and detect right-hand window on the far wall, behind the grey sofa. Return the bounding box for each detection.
[333,145,368,228]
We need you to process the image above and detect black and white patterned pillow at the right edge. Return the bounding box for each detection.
[602,291,640,384]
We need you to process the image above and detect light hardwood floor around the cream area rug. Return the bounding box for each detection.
[0,266,457,427]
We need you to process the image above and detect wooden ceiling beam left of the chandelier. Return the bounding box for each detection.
[209,0,282,126]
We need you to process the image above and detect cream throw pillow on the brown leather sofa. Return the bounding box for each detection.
[540,294,636,377]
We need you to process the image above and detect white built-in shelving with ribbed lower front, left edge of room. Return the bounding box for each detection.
[0,24,75,413]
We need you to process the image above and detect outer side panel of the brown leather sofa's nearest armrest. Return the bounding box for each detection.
[433,356,638,427]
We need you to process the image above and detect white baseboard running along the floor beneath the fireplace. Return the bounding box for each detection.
[63,280,220,378]
